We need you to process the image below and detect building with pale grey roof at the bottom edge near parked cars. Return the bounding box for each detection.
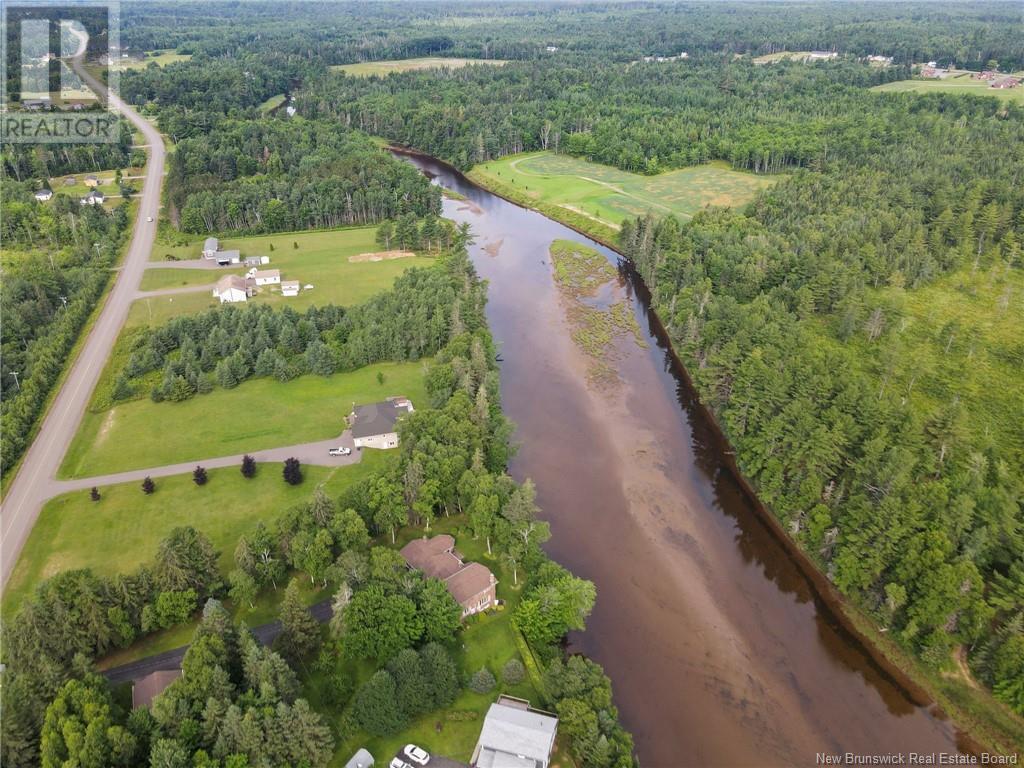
[470,694,558,768]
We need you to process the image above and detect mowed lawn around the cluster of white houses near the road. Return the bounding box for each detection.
[133,226,433,327]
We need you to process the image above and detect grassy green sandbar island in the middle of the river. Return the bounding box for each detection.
[550,240,646,385]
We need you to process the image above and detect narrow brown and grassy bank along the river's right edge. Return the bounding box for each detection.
[386,143,1021,756]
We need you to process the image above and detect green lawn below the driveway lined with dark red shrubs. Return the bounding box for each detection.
[3,451,395,614]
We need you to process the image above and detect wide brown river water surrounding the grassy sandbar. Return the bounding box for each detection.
[393,156,967,768]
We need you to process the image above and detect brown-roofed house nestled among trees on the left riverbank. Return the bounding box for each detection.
[401,534,498,617]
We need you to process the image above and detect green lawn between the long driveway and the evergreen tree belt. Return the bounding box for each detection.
[60,362,427,477]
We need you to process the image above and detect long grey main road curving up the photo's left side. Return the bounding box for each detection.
[0,41,166,588]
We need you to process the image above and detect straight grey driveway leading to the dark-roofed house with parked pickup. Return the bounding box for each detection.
[57,430,362,498]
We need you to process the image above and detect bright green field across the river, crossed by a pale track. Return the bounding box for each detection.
[470,152,778,228]
